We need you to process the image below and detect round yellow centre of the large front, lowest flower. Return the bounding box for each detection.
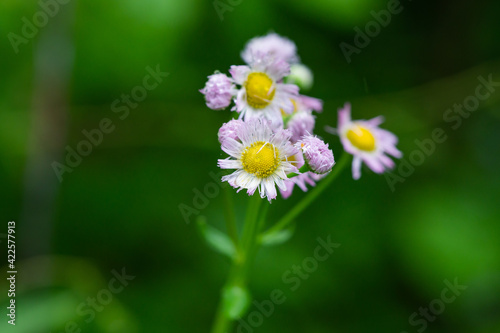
[241,141,280,178]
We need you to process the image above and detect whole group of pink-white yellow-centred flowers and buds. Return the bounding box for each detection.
[200,33,401,201]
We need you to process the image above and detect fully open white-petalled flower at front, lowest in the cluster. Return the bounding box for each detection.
[218,119,298,201]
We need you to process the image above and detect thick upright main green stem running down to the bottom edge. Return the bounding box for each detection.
[211,194,264,333]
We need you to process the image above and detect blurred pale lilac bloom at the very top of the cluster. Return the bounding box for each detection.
[241,33,299,64]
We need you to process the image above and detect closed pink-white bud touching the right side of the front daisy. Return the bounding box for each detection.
[295,134,335,175]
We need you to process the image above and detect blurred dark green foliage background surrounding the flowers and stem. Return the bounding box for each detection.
[0,0,500,333]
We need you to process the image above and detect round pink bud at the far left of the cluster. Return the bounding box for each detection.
[200,73,236,110]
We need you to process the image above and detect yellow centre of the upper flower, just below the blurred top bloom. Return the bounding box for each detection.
[244,72,276,109]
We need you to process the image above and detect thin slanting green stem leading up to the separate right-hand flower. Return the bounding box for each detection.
[261,153,351,237]
